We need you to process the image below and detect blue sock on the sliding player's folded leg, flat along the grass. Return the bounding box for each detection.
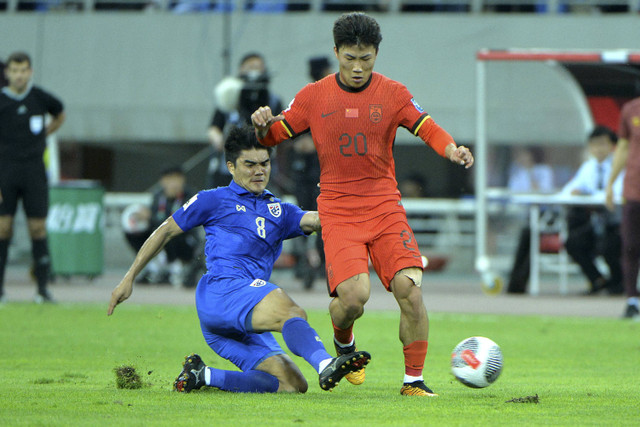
[205,367,280,393]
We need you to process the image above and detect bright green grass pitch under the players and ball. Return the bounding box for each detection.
[0,302,640,426]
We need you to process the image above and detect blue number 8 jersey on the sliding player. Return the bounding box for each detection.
[173,181,306,281]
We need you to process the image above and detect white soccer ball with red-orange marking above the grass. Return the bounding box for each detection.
[451,337,502,388]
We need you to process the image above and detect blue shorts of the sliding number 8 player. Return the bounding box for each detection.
[196,274,285,371]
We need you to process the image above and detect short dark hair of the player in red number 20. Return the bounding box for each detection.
[333,12,382,52]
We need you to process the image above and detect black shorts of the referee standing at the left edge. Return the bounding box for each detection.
[0,159,49,218]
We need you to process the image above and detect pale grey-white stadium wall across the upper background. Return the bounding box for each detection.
[0,13,640,144]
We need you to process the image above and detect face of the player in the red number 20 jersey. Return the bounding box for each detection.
[333,45,378,89]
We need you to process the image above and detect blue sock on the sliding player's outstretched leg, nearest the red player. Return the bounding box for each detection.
[282,317,332,372]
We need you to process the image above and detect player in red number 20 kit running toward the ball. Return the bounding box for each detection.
[251,12,473,396]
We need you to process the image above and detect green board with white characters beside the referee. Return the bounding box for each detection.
[47,180,104,276]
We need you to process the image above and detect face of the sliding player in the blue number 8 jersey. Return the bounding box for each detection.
[227,148,271,194]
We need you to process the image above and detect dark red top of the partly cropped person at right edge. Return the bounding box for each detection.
[618,98,640,202]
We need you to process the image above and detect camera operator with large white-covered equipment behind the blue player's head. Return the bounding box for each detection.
[207,52,282,188]
